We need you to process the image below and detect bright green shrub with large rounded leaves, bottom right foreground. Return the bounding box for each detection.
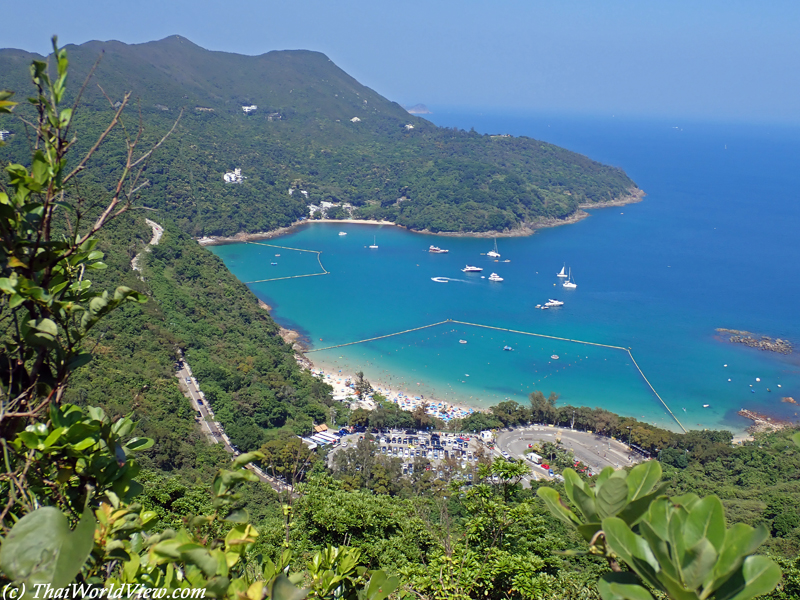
[537,461,781,600]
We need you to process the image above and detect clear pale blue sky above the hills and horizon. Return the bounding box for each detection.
[6,0,800,123]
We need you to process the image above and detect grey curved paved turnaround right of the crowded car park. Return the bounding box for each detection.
[496,425,637,478]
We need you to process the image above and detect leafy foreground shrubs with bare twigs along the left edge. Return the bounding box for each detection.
[0,38,398,600]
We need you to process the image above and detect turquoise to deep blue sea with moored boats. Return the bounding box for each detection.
[212,111,800,432]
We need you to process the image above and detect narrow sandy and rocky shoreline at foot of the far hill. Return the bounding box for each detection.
[195,188,646,246]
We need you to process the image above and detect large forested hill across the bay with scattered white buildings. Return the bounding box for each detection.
[0,36,636,236]
